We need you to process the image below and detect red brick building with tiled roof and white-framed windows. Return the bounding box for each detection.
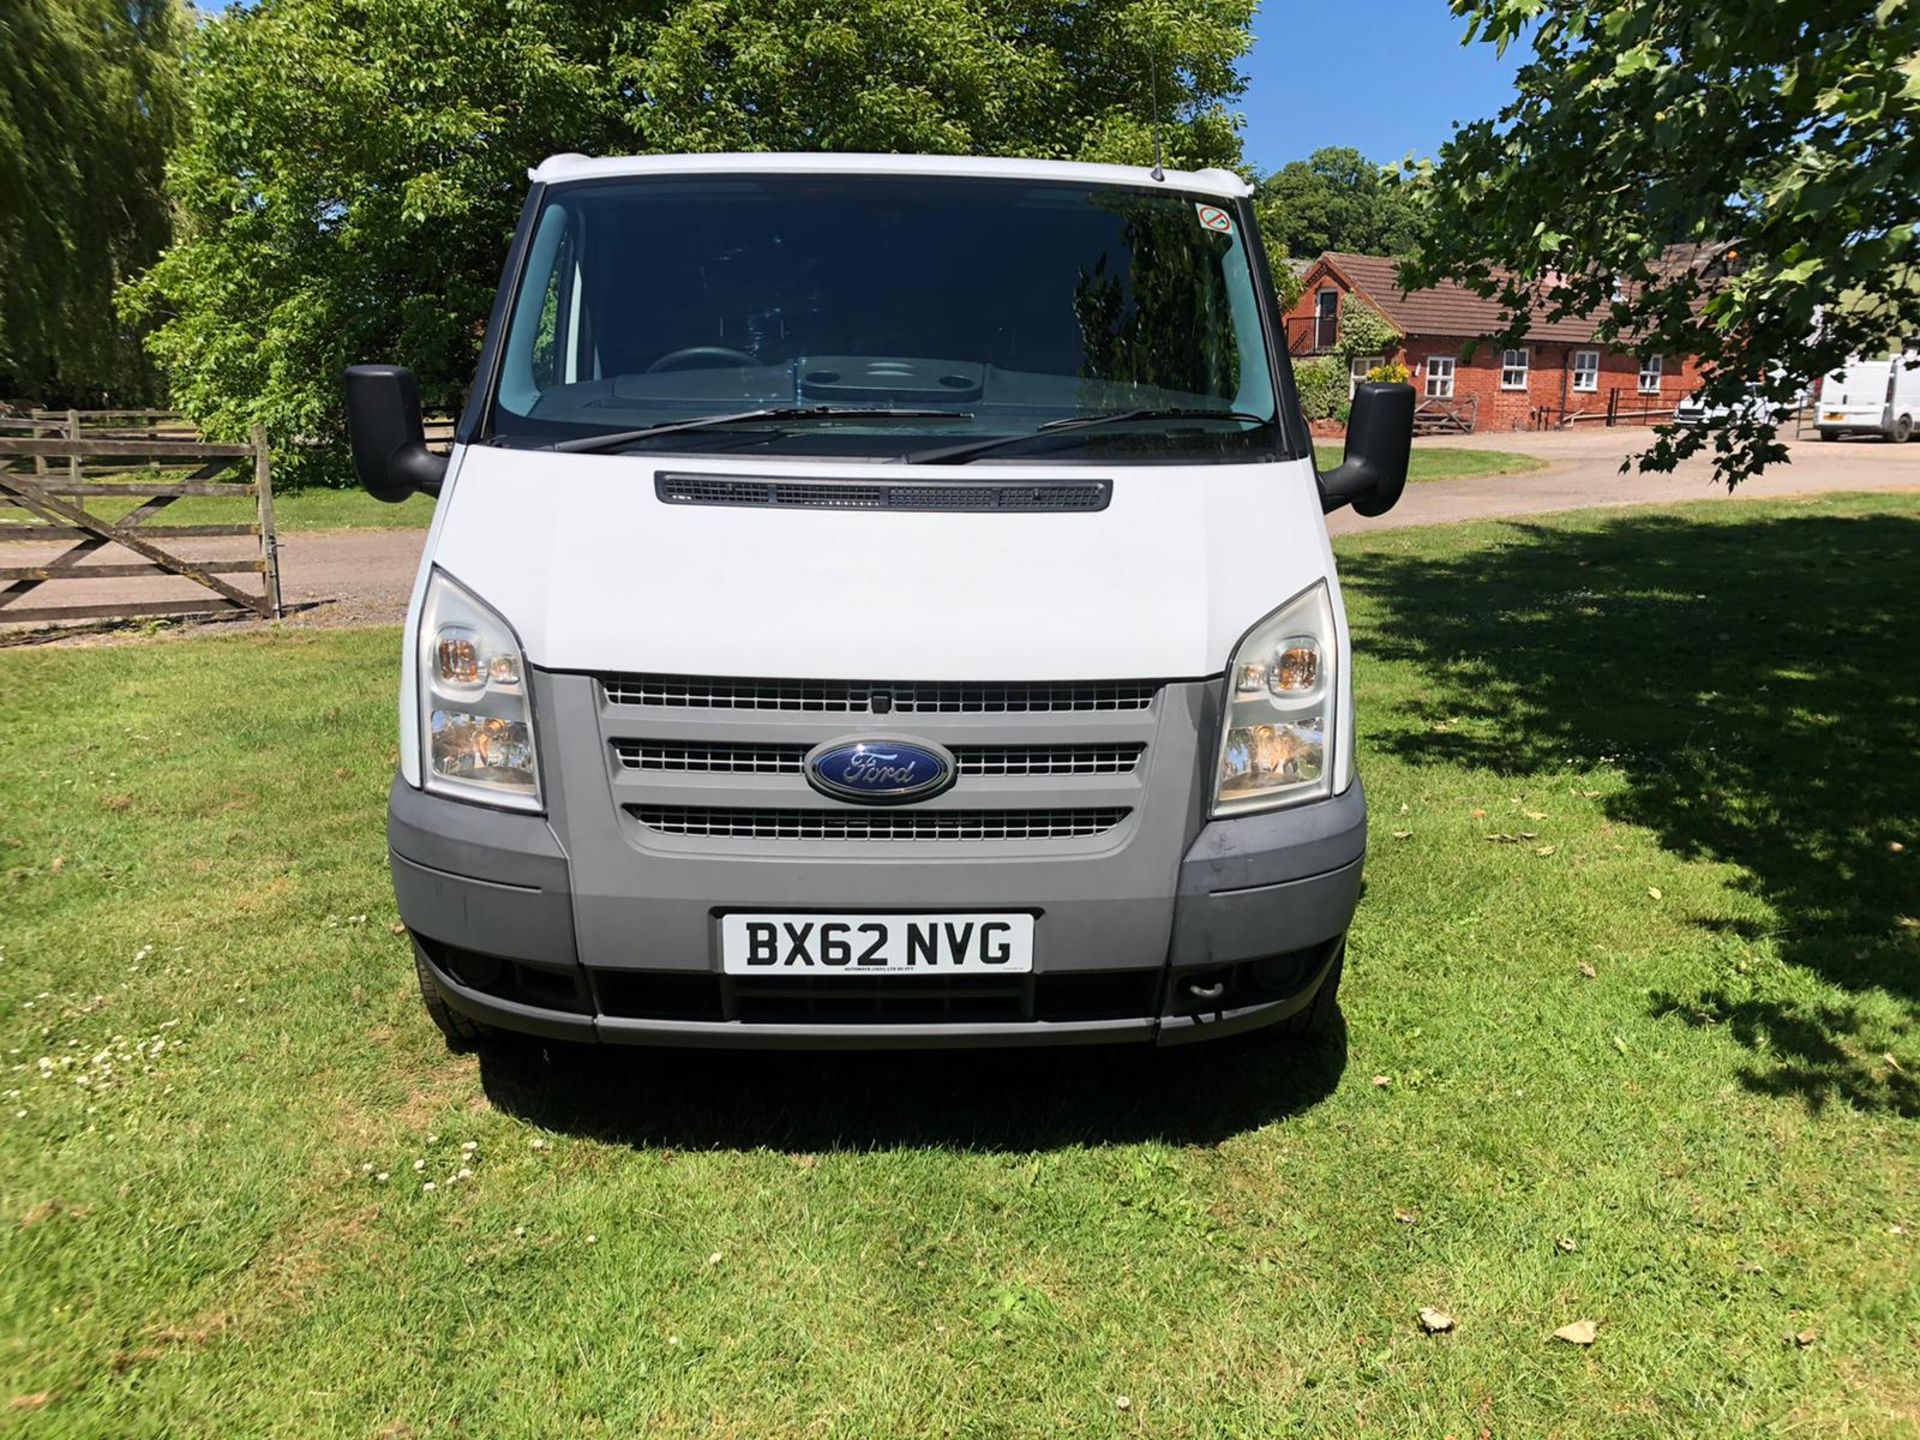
[1286,252,1699,430]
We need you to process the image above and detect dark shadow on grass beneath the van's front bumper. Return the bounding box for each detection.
[480,1021,1346,1152]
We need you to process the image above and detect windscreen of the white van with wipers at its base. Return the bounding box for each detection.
[486,175,1281,463]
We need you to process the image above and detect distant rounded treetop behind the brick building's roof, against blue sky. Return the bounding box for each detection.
[1254,146,1425,259]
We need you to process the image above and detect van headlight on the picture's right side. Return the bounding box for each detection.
[1213,580,1338,816]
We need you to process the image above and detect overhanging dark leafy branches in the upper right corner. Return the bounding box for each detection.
[1402,0,1920,484]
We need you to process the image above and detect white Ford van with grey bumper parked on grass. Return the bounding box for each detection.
[348,156,1413,1046]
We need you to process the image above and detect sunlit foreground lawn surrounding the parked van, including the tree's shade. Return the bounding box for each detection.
[0,495,1920,1440]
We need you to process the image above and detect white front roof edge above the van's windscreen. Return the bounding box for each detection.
[526,152,1252,200]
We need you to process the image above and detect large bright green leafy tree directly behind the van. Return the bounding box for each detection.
[127,0,1252,485]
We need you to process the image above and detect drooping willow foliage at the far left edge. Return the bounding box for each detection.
[0,0,190,403]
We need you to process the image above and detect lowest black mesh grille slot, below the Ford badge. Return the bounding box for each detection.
[628,804,1129,841]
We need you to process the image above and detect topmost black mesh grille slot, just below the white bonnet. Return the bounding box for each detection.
[601,676,1162,714]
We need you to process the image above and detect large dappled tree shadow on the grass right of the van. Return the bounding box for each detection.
[1342,505,1920,1116]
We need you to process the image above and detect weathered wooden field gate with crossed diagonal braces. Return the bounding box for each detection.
[0,426,282,626]
